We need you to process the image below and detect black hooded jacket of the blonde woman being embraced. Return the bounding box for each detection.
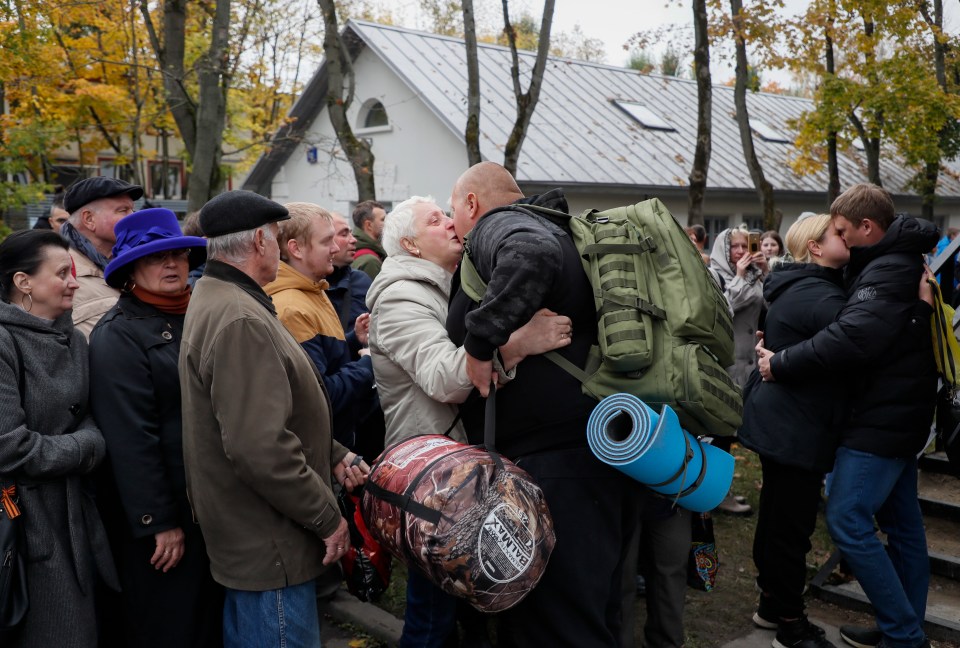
[737,263,847,472]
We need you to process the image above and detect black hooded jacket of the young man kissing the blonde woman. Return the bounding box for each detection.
[770,216,938,457]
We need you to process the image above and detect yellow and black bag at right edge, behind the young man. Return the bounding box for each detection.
[927,279,960,464]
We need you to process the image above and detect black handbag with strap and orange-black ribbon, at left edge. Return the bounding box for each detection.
[0,336,30,644]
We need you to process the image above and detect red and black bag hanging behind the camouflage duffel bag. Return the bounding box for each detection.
[337,488,390,602]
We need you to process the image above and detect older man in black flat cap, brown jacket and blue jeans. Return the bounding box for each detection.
[180,191,369,648]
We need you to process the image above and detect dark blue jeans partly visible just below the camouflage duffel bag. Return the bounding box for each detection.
[398,568,458,648]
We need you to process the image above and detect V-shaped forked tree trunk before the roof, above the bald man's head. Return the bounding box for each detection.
[502,0,556,177]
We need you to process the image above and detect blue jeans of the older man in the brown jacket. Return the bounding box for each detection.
[223,580,320,648]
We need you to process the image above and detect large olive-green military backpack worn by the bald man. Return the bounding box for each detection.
[460,198,743,436]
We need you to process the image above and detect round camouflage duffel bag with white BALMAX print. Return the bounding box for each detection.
[362,435,555,612]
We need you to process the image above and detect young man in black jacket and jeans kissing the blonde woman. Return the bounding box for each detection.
[758,184,937,648]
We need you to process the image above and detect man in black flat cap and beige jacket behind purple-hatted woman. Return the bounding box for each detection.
[61,176,143,339]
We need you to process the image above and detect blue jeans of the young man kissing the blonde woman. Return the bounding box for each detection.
[827,448,930,648]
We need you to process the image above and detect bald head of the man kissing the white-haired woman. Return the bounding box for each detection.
[450,162,523,241]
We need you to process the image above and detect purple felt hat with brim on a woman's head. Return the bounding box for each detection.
[103,207,207,288]
